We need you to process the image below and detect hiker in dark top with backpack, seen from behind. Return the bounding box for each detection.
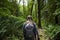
[23,15,38,40]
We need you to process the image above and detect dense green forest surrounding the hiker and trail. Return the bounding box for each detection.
[0,0,60,40]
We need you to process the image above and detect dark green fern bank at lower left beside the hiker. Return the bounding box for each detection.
[0,13,25,40]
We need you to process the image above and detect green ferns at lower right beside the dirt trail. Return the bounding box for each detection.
[45,25,60,40]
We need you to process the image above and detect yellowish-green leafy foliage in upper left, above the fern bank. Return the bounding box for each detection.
[0,0,20,16]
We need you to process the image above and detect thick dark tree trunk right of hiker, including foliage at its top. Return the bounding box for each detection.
[37,0,44,28]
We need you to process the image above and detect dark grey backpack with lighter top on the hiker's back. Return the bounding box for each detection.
[25,23,34,37]
